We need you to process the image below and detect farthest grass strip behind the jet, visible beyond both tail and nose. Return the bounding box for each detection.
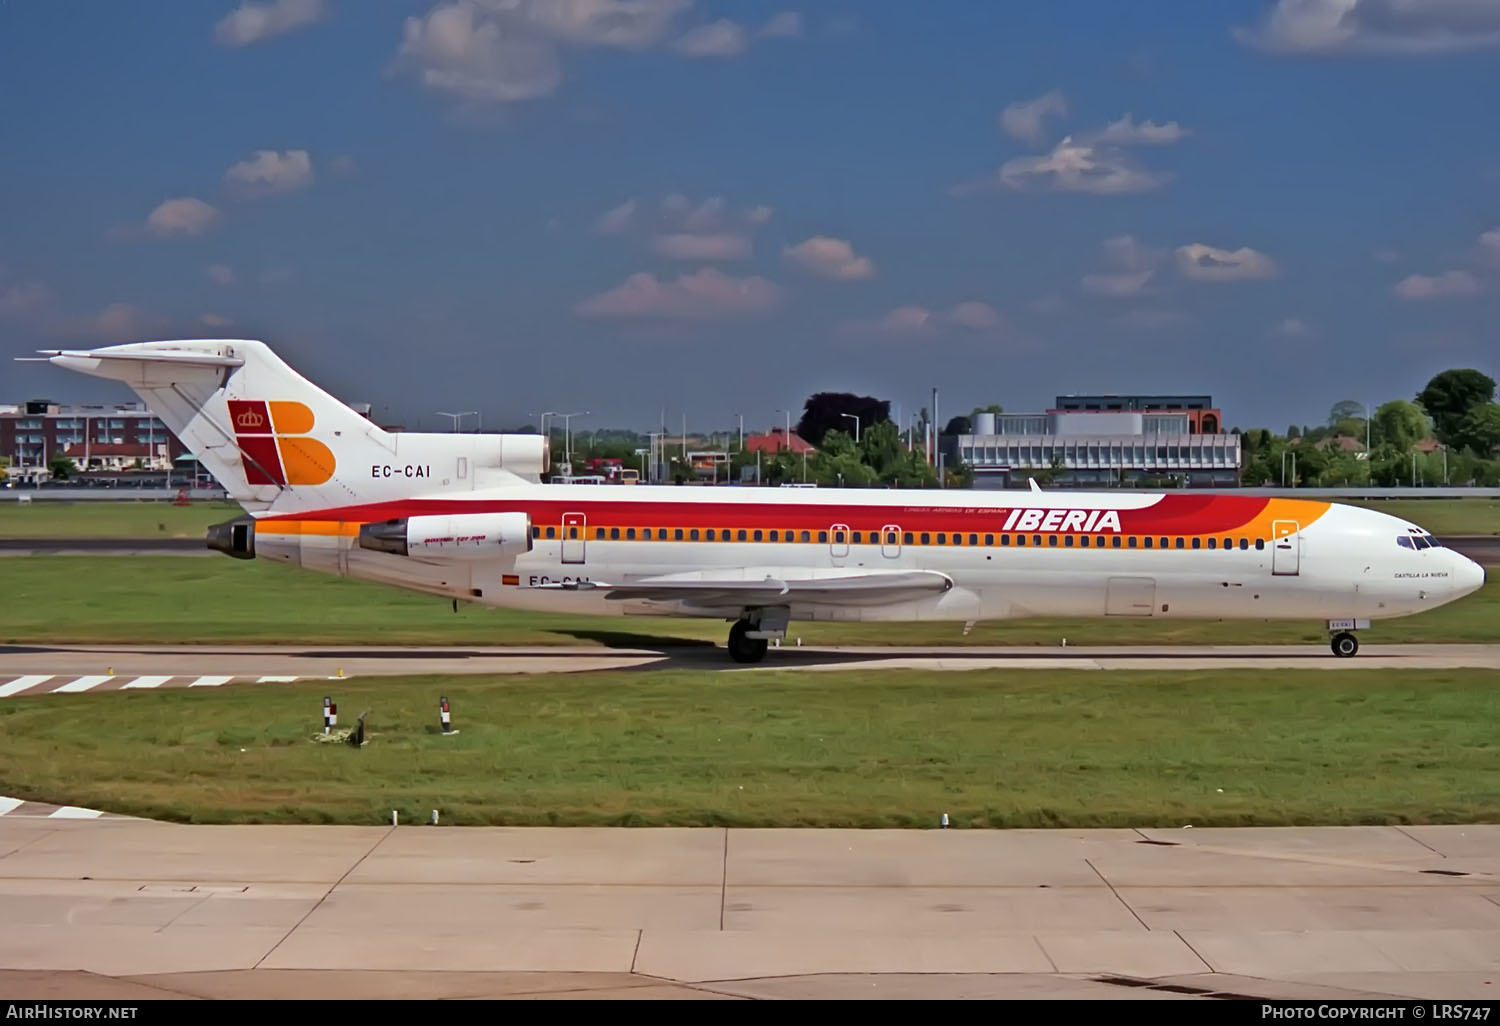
[0,498,1500,539]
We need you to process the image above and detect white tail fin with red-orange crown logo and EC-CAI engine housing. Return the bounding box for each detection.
[33,339,549,513]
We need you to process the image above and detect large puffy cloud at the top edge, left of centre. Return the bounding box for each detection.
[389,0,563,104]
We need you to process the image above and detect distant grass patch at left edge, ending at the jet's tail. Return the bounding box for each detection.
[0,492,245,540]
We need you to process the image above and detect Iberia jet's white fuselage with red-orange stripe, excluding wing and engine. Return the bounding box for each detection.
[255,485,1484,621]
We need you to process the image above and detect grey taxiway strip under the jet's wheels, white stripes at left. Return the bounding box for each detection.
[0,644,1500,699]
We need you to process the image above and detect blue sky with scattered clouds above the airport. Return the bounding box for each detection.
[0,0,1500,432]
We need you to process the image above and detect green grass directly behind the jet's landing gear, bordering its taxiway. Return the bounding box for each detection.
[0,555,1500,647]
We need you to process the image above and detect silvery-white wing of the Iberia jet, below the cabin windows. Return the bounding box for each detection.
[543,567,953,609]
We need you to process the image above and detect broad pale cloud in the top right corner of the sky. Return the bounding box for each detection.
[1235,0,1500,56]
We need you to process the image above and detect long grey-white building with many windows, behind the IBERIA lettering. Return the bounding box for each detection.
[953,396,1241,488]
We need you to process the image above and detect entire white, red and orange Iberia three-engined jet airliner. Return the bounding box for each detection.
[32,341,1485,663]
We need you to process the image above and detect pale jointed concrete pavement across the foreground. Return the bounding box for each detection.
[0,810,1500,1001]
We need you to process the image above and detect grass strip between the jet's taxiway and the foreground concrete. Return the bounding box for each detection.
[0,671,1500,828]
